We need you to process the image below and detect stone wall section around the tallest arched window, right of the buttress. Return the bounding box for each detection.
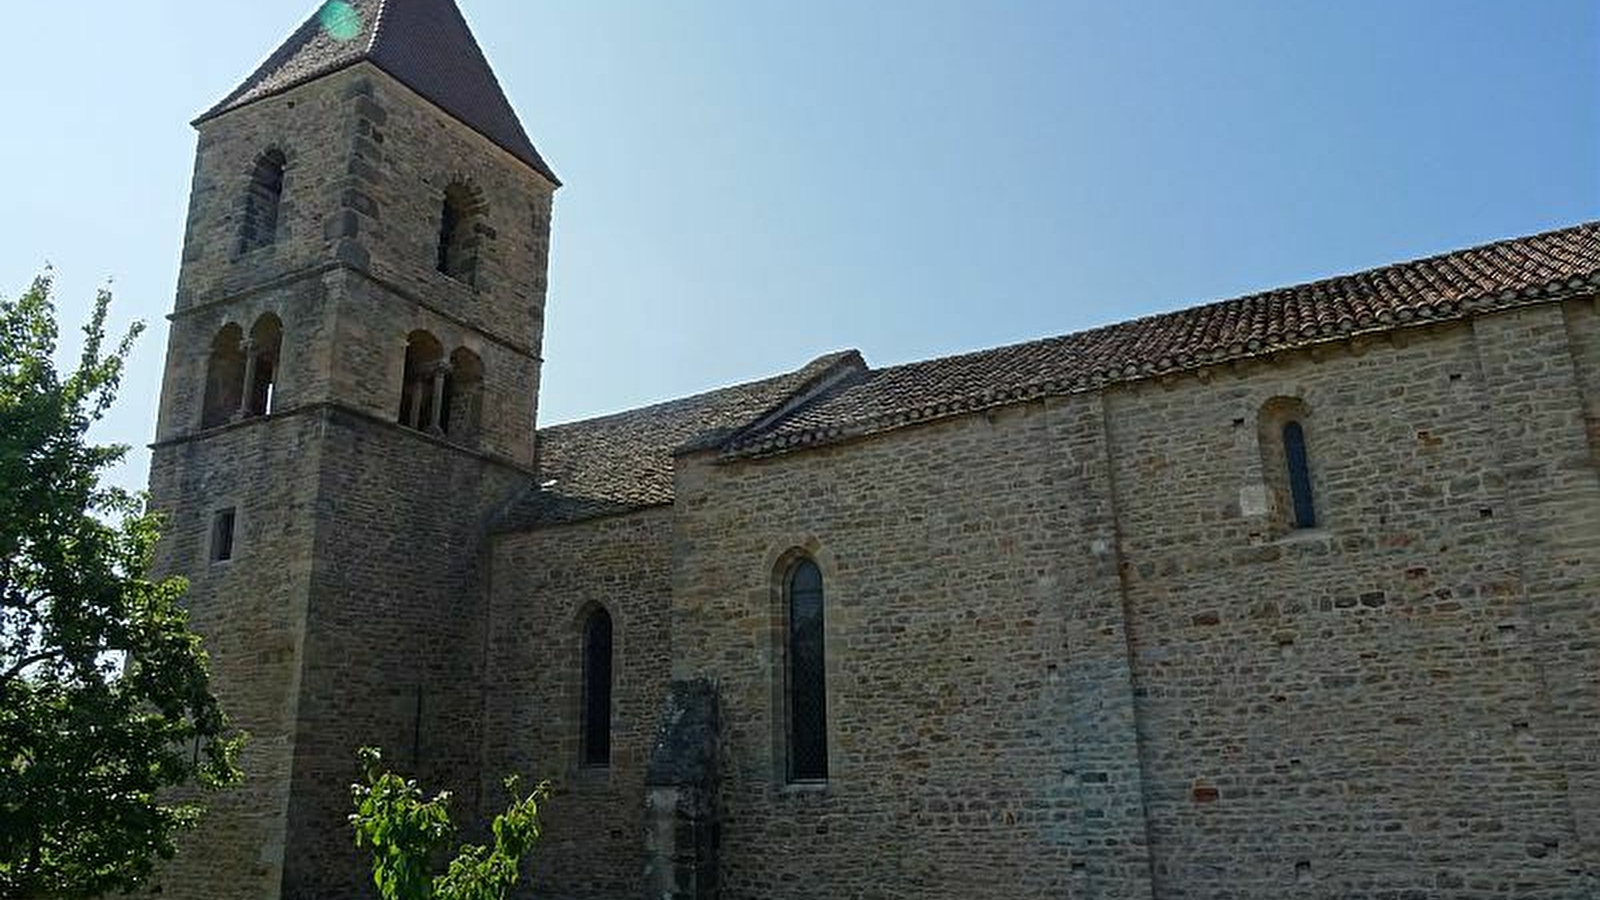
[672,396,1150,900]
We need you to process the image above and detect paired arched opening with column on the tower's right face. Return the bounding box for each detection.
[398,331,483,444]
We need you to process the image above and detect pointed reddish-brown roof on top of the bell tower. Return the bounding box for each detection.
[195,0,560,184]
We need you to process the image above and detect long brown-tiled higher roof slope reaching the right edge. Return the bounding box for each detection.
[723,223,1600,456]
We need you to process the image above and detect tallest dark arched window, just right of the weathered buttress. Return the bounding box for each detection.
[784,559,827,781]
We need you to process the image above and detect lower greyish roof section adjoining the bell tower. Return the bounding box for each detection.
[499,351,866,528]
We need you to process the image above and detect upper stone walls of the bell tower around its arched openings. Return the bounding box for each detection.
[172,62,554,466]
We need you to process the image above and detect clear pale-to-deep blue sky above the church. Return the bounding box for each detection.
[0,0,1600,487]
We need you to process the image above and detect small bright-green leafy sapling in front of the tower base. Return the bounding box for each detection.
[350,748,549,900]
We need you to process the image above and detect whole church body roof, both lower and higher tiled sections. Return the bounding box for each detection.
[501,223,1600,528]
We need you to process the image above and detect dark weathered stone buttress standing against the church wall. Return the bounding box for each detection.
[645,679,722,900]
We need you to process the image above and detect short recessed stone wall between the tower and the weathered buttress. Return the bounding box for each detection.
[483,509,672,900]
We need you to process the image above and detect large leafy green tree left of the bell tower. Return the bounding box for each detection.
[0,274,242,900]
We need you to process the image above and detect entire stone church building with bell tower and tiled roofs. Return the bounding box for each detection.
[150,0,1600,900]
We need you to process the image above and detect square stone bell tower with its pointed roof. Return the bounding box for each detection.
[150,0,560,900]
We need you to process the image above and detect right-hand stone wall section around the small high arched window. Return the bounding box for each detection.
[1109,306,1595,898]
